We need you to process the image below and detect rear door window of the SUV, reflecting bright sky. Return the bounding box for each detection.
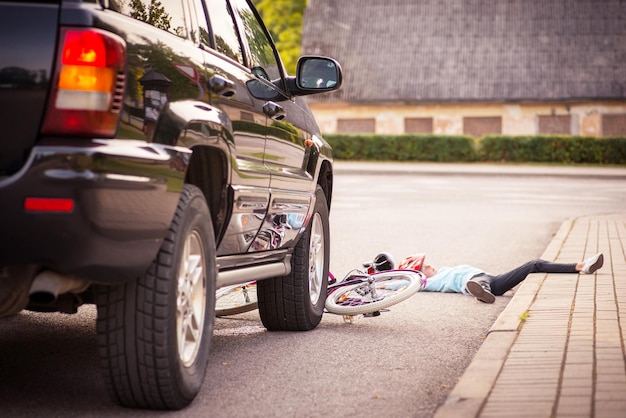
[205,0,243,64]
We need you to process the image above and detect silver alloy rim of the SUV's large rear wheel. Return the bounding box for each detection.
[176,231,207,367]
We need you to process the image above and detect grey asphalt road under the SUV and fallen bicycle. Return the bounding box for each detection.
[0,165,626,418]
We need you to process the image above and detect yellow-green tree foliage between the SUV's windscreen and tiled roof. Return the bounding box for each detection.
[254,0,307,74]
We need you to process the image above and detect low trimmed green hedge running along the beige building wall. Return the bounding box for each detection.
[324,134,626,165]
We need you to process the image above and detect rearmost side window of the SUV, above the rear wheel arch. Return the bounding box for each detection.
[111,0,189,38]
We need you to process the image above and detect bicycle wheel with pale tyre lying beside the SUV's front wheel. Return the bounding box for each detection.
[326,270,423,315]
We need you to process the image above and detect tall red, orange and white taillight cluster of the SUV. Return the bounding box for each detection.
[42,28,126,137]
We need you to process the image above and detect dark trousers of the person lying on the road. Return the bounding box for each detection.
[475,259,578,296]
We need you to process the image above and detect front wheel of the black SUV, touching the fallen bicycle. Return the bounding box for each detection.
[257,186,330,331]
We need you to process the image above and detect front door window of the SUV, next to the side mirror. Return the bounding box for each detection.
[231,0,281,85]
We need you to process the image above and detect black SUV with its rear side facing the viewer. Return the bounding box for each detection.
[0,0,341,409]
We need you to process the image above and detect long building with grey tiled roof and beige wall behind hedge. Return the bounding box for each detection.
[302,0,626,137]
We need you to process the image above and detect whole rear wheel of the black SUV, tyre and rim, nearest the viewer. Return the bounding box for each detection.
[96,185,217,410]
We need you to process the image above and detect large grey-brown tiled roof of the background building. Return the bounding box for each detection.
[302,0,626,102]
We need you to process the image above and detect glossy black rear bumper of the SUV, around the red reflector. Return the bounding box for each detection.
[0,140,189,283]
